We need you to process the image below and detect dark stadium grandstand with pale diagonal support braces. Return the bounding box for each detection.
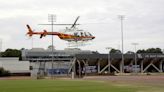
[75,53,164,77]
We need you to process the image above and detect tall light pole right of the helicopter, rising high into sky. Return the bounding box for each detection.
[118,15,125,73]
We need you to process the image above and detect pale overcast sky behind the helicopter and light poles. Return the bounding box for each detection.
[0,0,164,53]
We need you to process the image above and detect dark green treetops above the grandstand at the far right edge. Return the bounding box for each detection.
[137,48,162,53]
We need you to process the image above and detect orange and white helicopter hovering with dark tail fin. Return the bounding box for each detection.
[26,16,95,42]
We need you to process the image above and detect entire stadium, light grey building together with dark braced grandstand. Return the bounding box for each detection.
[22,48,164,77]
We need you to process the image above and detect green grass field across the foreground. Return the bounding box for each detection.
[0,80,163,92]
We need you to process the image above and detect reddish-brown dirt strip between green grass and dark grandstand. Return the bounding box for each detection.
[84,75,164,86]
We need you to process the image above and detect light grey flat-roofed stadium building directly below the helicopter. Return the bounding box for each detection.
[22,48,93,77]
